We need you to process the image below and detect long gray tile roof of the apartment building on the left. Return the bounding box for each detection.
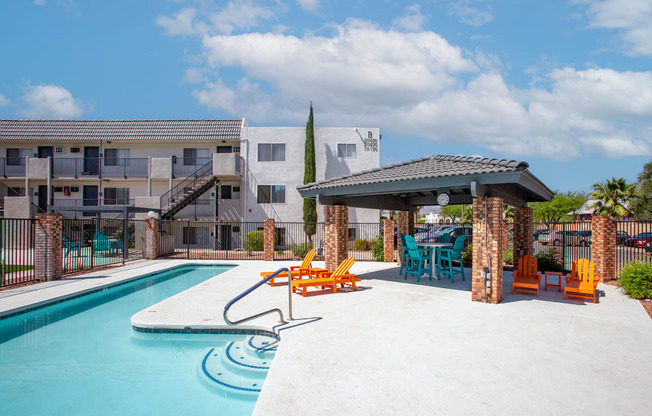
[0,120,242,140]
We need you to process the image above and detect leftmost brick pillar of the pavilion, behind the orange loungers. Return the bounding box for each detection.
[324,205,349,271]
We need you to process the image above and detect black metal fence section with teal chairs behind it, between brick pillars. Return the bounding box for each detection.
[62,218,145,274]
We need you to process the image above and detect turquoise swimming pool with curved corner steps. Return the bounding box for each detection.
[0,266,274,415]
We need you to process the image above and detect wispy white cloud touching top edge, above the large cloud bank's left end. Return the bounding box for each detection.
[156,0,273,36]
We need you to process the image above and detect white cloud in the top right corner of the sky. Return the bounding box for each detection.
[580,0,652,56]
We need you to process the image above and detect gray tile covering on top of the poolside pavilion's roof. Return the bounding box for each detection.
[298,155,529,190]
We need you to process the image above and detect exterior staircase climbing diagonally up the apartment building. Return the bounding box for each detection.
[161,161,219,220]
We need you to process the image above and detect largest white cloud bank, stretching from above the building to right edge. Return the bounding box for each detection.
[160,6,652,160]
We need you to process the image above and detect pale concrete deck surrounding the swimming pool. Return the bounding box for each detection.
[0,260,652,415]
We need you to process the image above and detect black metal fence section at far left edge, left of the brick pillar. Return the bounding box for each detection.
[0,218,36,286]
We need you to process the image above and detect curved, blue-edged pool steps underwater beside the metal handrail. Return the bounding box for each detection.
[200,336,275,395]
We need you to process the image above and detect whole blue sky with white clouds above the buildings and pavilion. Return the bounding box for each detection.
[0,0,652,191]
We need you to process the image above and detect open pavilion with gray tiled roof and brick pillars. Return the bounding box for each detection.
[298,155,612,303]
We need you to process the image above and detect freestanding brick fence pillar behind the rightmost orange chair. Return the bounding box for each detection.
[591,215,616,282]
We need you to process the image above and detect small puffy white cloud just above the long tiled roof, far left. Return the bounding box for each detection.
[23,85,91,119]
